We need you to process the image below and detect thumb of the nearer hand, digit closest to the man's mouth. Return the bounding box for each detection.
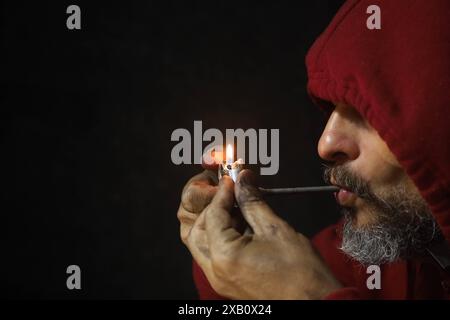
[234,170,286,235]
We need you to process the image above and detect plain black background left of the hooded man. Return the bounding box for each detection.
[1,0,342,299]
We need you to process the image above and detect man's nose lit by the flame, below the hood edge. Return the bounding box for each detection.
[317,112,359,164]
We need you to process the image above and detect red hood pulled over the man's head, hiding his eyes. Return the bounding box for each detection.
[306,0,450,240]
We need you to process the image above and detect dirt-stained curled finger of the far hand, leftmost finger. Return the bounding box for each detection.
[181,170,218,213]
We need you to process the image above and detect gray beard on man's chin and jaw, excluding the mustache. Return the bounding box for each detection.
[340,204,442,266]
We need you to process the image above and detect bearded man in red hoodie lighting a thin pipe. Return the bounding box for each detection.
[178,0,450,299]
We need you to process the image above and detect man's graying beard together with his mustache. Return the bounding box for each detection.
[324,165,443,265]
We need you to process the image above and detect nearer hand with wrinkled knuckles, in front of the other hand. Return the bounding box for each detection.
[179,170,341,299]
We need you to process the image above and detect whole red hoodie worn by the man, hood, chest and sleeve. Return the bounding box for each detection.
[193,0,450,299]
